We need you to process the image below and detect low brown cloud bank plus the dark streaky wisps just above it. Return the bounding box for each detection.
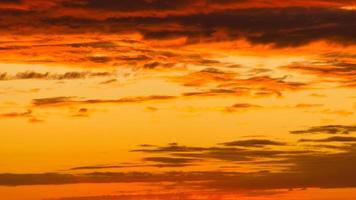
[0,125,356,192]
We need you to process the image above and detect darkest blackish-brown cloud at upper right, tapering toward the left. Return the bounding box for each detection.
[122,8,355,47]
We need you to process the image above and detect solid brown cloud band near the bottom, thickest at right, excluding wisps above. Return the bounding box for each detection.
[0,145,356,191]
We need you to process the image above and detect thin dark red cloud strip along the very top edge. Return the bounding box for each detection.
[52,0,356,15]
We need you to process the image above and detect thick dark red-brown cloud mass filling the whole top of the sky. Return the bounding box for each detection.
[0,0,356,47]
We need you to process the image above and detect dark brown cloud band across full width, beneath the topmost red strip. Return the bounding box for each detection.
[0,6,356,47]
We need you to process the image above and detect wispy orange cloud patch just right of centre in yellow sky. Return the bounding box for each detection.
[177,73,309,97]
